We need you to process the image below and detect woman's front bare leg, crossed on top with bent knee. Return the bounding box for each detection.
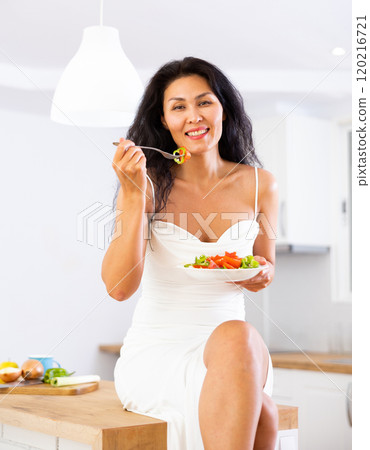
[199,320,268,450]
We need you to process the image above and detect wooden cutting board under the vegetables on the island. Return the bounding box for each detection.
[0,382,99,395]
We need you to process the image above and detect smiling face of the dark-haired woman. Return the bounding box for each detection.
[162,75,225,154]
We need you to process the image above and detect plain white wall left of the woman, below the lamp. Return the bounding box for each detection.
[0,107,140,379]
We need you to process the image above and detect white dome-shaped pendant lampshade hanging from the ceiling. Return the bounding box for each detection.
[51,26,143,127]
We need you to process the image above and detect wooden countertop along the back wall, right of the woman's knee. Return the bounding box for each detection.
[271,352,352,374]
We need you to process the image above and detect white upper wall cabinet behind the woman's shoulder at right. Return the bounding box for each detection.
[253,113,337,246]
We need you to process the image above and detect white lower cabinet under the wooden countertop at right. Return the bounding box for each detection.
[273,369,352,450]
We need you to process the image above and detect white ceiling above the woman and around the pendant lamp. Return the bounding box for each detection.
[0,0,351,119]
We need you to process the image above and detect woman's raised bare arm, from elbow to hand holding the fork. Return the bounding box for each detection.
[101,141,151,301]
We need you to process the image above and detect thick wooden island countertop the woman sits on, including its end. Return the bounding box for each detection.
[0,381,298,450]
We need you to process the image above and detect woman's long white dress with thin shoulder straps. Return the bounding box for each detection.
[114,168,273,450]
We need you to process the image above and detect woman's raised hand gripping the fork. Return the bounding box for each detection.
[112,138,147,196]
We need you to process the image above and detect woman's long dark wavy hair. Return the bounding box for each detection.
[114,57,262,219]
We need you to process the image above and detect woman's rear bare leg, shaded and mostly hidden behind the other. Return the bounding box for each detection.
[253,393,279,450]
